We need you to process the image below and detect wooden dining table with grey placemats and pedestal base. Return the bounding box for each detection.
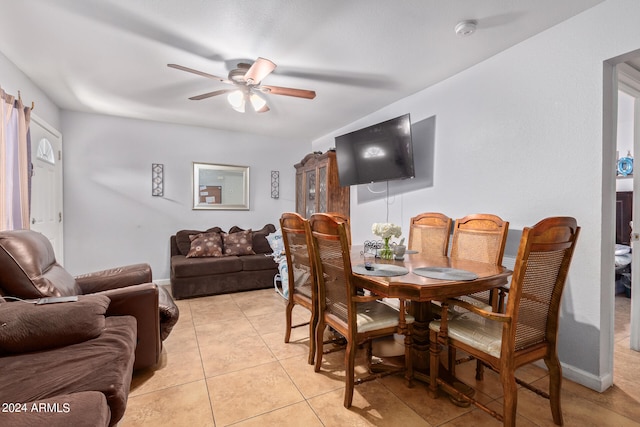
[351,245,512,379]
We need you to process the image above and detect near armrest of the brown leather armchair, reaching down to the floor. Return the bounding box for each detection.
[100,283,162,369]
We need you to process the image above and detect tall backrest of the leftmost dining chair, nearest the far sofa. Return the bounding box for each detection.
[280,212,316,300]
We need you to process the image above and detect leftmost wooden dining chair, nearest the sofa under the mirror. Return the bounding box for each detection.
[280,212,318,365]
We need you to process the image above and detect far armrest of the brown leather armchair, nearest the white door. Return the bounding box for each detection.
[75,263,152,294]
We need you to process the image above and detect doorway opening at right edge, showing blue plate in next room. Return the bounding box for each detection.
[601,50,640,394]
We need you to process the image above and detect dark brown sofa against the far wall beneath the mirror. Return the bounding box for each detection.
[170,224,278,299]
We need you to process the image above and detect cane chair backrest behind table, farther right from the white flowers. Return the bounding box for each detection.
[450,214,509,265]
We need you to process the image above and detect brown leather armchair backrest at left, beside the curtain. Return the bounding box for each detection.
[0,230,82,298]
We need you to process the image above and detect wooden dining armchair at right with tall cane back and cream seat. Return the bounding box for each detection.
[429,217,580,426]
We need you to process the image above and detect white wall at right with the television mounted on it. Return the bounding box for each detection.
[313,0,640,389]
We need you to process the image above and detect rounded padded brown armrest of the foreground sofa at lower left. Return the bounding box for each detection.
[0,295,111,354]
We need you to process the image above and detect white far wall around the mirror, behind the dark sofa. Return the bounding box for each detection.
[62,111,309,280]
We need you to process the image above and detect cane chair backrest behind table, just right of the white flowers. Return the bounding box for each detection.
[408,212,452,256]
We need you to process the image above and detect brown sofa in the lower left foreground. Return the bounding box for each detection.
[0,294,137,427]
